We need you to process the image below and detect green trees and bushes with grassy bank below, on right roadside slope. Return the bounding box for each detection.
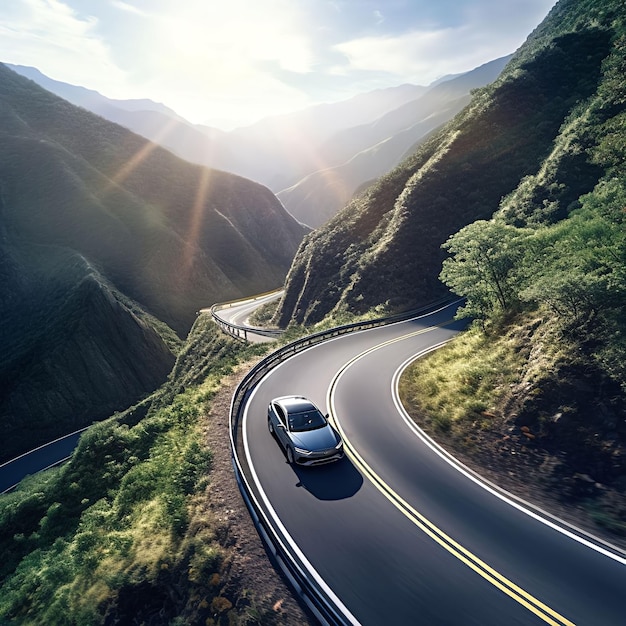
[404,2,626,541]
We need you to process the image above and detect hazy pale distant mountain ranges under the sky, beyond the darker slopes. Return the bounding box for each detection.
[9,57,510,227]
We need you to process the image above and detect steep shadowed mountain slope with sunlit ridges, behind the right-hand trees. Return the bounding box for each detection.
[277,2,617,325]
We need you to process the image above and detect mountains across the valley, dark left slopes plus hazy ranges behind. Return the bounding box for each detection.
[0,53,505,460]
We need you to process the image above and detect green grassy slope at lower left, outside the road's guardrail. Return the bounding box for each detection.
[0,316,272,625]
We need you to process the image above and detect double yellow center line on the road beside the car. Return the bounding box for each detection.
[328,320,575,626]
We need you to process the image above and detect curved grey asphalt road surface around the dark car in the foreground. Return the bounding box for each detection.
[243,308,626,626]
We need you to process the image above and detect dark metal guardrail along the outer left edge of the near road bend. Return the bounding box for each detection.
[229,297,458,626]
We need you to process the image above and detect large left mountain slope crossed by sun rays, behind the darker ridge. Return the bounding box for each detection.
[0,67,305,332]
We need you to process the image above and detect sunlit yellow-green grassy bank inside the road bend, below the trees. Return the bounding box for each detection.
[399,309,626,546]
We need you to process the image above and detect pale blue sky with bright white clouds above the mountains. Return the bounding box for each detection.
[0,0,556,130]
